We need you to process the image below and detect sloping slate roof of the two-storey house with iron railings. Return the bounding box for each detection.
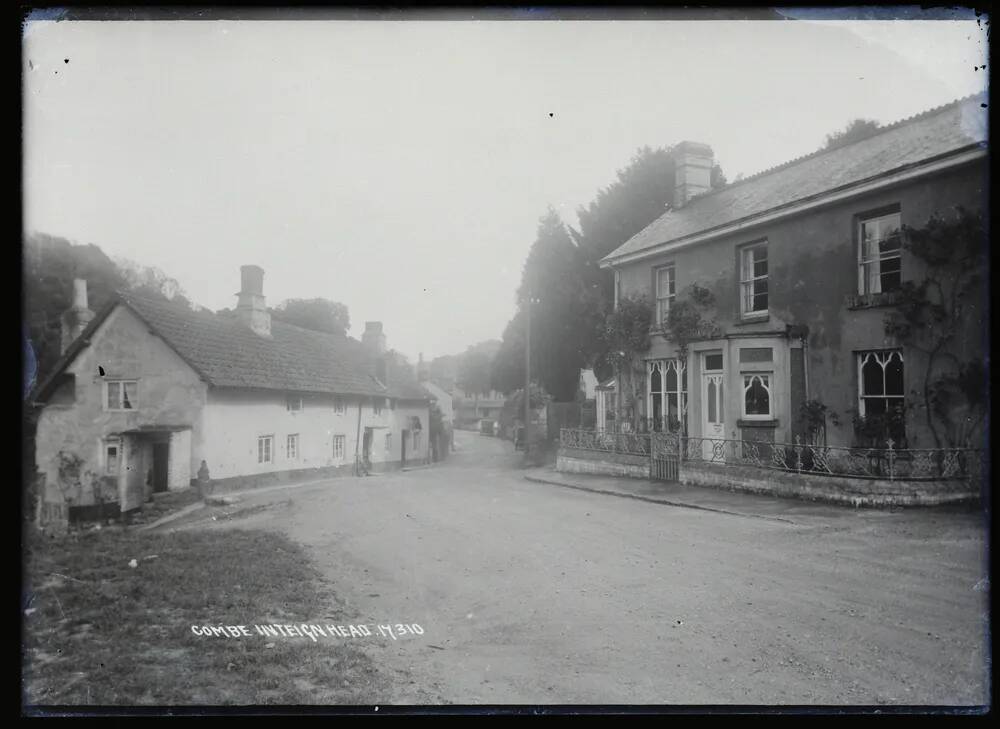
[603,94,988,263]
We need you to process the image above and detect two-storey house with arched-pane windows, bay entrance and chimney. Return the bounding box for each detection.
[598,96,989,448]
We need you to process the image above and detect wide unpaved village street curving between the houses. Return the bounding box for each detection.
[168,432,989,704]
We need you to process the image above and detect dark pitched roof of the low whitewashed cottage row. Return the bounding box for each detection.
[30,293,427,400]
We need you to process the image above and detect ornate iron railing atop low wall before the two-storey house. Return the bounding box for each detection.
[560,428,986,483]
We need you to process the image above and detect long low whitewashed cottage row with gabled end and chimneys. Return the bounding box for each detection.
[33,266,429,523]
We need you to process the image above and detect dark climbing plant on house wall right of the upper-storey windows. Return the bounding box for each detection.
[885,207,989,448]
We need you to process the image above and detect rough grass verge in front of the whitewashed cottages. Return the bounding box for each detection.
[22,529,385,711]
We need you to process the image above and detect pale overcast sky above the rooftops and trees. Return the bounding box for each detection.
[23,14,988,361]
